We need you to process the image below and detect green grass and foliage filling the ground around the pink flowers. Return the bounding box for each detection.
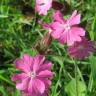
[0,0,96,96]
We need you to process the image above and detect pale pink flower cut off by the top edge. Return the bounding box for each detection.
[35,0,52,15]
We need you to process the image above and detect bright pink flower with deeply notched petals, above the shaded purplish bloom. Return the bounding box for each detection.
[51,10,85,46]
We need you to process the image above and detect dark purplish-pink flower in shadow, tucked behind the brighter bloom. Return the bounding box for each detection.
[68,37,94,59]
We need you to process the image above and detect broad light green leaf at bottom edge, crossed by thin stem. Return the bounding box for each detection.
[65,79,86,96]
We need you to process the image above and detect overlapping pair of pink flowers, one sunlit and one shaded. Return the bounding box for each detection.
[39,10,94,59]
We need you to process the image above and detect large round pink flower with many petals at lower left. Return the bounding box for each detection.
[12,54,53,96]
